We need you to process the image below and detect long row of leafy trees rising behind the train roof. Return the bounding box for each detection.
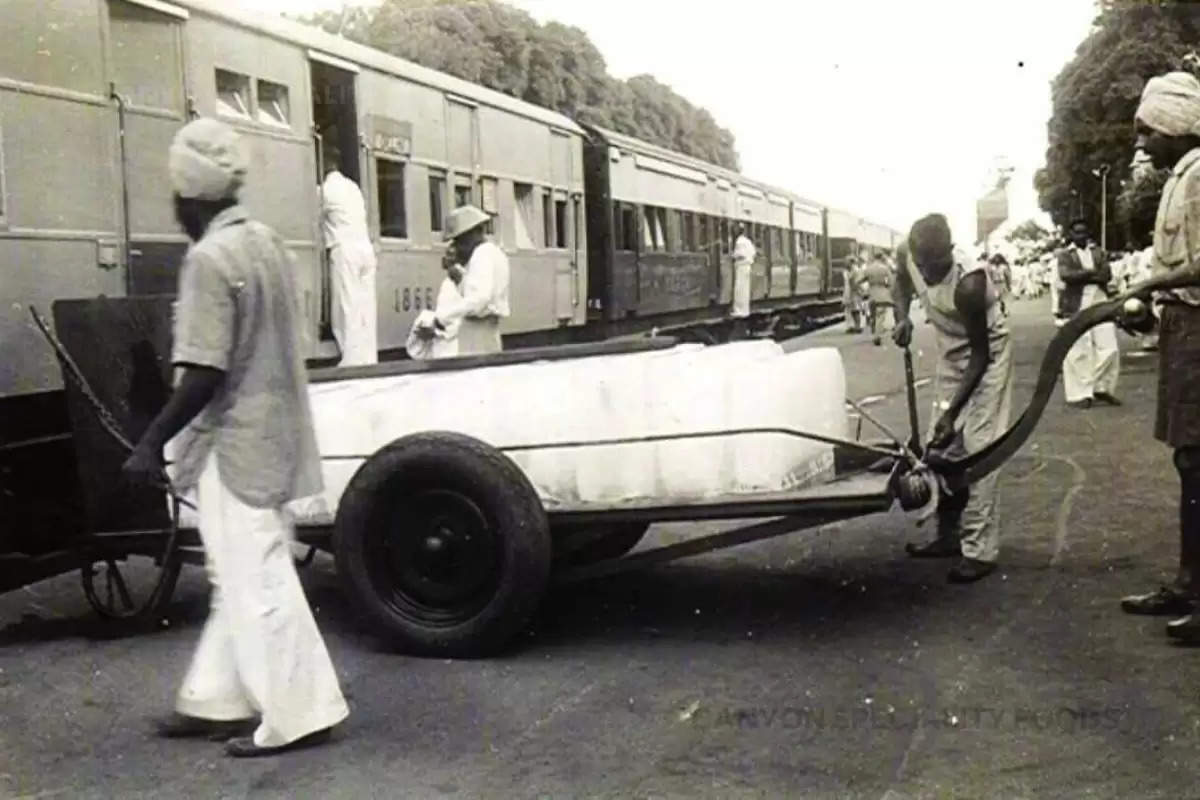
[292,0,739,169]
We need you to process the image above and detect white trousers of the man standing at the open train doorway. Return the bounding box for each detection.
[329,240,379,367]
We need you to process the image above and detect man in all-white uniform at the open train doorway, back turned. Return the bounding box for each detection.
[320,145,379,367]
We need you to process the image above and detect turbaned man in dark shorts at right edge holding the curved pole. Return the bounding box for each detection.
[1121,72,1200,643]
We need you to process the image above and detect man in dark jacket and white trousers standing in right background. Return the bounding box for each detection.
[1056,219,1121,409]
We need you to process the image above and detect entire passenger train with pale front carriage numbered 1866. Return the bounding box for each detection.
[0,0,896,520]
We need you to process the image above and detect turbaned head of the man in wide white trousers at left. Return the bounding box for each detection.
[167,118,247,241]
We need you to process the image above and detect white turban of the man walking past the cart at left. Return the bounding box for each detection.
[167,118,246,200]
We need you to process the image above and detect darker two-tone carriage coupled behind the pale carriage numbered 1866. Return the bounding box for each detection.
[584,126,828,336]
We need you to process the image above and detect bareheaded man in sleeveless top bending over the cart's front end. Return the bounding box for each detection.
[893,213,1013,583]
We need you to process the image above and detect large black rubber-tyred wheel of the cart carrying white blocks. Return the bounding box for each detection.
[334,432,551,657]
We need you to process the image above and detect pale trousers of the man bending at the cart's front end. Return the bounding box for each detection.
[934,344,1013,561]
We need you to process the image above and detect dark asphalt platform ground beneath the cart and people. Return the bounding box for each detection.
[0,301,1200,800]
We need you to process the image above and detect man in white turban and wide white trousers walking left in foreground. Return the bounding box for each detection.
[124,119,349,757]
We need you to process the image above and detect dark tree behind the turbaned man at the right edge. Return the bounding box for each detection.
[1034,0,1200,248]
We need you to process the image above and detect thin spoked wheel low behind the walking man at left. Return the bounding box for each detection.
[79,553,184,620]
